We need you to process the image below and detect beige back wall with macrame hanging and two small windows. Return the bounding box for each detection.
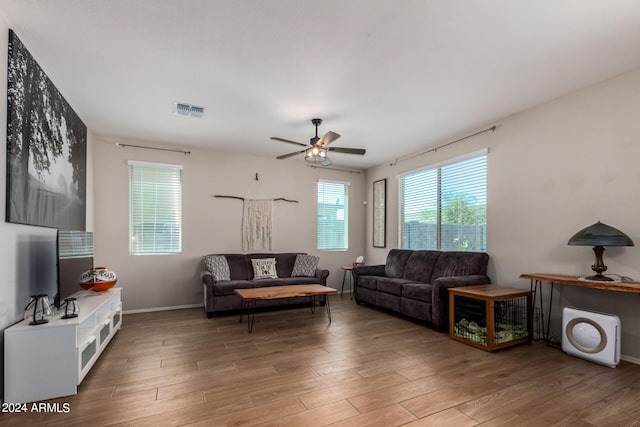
[95,137,365,310]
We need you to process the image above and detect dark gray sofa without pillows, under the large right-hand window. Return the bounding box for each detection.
[352,249,491,331]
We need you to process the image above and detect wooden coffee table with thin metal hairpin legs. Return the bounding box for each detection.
[234,285,338,333]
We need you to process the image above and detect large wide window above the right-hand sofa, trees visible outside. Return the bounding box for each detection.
[400,154,487,251]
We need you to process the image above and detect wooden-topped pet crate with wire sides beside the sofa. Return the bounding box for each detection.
[449,285,533,351]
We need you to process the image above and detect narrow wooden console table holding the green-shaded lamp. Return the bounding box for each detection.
[520,273,640,343]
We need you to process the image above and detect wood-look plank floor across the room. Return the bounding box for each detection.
[5,295,640,427]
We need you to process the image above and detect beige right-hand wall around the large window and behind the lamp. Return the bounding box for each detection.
[367,70,640,360]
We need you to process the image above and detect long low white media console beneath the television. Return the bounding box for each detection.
[4,288,122,403]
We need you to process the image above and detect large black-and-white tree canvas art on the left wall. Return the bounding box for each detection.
[6,30,87,230]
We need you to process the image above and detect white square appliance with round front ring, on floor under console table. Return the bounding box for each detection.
[562,307,620,368]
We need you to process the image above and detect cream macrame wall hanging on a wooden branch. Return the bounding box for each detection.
[214,194,298,252]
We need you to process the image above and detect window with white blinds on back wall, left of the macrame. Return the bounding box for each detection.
[129,161,182,255]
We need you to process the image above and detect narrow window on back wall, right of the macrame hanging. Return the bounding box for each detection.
[318,181,349,250]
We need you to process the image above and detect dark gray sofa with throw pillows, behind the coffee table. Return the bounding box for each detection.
[200,253,329,318]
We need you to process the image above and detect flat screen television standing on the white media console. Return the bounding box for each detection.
[54,230,93,307]
